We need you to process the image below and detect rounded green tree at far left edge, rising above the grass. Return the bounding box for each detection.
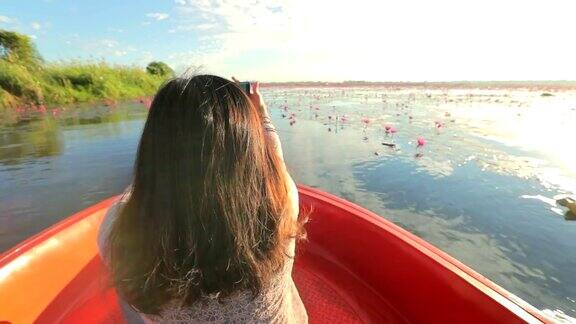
[0,30,42,68]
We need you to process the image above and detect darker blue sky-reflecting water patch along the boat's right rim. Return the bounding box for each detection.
[354,161,576,308]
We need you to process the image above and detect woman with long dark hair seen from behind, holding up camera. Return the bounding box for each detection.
[99,75,307,323]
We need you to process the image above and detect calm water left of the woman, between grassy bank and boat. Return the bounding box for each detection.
[0,104,147,250]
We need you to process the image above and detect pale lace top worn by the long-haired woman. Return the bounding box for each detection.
[98,191,308,323]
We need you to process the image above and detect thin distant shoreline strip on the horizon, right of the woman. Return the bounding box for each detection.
[262,81,576,91]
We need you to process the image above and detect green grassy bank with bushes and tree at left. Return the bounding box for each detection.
[0,30,174,110]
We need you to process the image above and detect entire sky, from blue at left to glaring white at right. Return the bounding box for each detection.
[0,0,576,81]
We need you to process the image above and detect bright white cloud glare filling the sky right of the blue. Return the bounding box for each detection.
[166,0,576,80]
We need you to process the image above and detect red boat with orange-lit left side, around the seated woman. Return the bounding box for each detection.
[0,186,552,324]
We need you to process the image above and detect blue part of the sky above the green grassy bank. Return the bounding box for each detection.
[0,0,191,64]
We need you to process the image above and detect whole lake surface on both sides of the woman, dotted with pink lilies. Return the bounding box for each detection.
[0,88,576,316]
